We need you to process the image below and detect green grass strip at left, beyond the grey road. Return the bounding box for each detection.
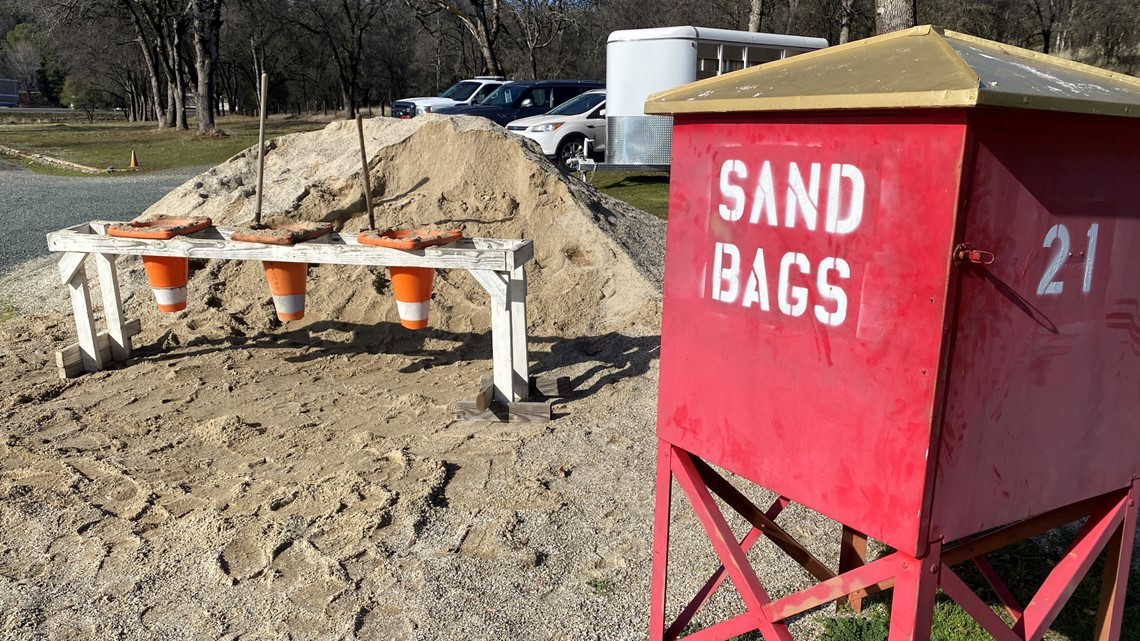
[0,116,326,171]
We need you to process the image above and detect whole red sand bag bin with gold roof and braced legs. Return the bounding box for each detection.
[645,26,1140,641]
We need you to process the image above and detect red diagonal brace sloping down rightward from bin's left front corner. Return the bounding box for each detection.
[673,449,793,641]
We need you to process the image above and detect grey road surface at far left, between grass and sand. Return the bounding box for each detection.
[0,161,206,276]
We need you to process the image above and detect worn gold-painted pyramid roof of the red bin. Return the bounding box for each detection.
[645,26,1140,117]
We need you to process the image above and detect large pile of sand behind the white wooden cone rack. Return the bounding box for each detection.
[144,116,665,336]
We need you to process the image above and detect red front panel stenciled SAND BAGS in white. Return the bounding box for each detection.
[658,112,966,554]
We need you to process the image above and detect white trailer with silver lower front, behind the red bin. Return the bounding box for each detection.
[586,26,828,170]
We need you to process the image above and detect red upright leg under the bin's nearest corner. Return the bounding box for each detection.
[888,542,942,641]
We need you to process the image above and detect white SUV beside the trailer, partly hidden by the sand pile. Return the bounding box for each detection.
[506,89,605,171]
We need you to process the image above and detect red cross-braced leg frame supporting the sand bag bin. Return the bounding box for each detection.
[649,439,1140,641]
